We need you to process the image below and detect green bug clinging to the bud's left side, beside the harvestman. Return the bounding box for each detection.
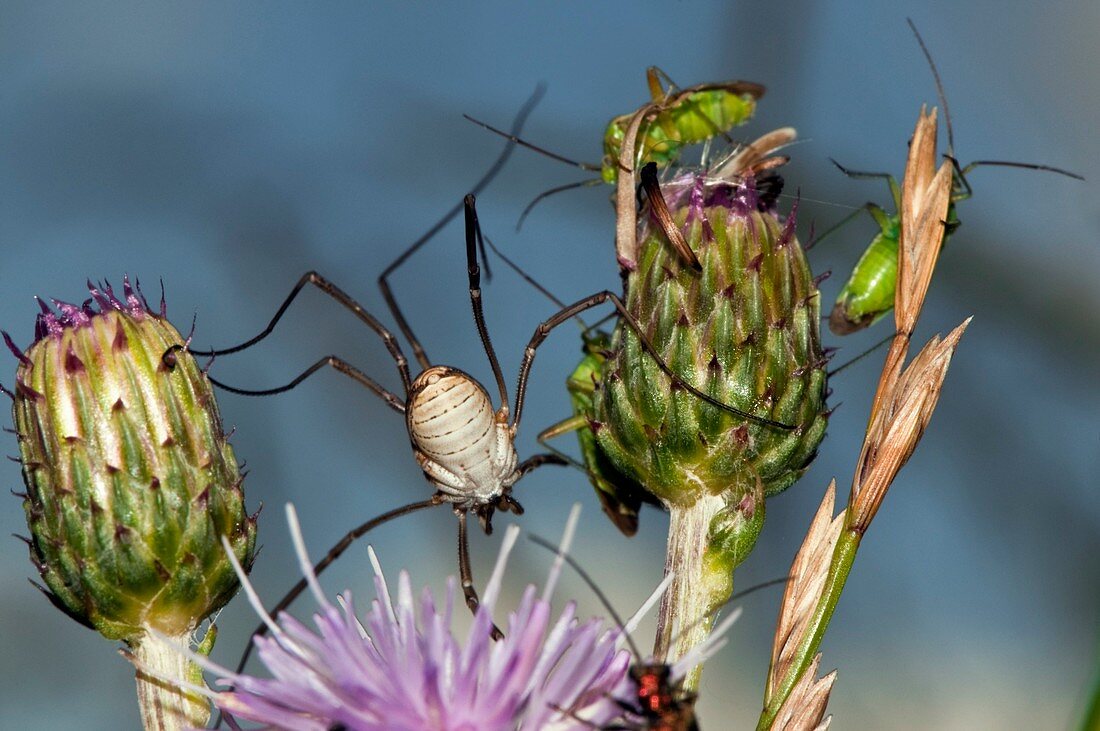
[538,330,656,536]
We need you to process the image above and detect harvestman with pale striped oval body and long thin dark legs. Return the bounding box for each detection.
[182,195,790,667]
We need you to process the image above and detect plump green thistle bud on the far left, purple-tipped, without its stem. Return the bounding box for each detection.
[4,281,255,644]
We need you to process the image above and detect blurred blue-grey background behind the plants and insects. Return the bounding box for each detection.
[0,0,1100,730]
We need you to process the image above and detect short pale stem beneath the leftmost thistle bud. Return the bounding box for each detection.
[132,634,210,731]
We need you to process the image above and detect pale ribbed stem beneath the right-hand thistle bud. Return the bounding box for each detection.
[653,495,733,690]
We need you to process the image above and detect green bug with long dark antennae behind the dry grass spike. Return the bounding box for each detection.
[818,21,1085,335]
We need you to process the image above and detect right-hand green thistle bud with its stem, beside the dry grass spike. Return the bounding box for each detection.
[593,167,826,672]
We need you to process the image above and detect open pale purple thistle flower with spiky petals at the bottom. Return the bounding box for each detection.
[170,506,668,731]
